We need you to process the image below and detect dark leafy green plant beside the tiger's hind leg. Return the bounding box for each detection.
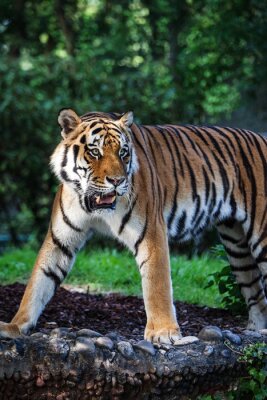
[206,245,246,313]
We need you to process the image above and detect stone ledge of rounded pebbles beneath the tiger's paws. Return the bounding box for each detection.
[0,327,267,400]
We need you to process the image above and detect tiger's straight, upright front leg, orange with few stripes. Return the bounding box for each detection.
[136,227,182,344]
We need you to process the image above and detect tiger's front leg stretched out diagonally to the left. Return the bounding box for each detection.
[0,188,88,338]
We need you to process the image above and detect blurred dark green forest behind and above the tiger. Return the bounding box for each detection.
[0,0,267,250]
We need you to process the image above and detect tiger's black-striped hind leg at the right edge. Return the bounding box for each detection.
[217,222,267,330]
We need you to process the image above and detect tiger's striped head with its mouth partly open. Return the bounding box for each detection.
[51,109,137,212]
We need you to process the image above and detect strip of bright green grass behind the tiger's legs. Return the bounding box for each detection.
[0,247,226,307]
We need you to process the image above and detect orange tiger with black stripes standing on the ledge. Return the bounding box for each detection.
[0,108,267,344]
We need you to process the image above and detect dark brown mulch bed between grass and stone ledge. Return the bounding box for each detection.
[0,283,246,340]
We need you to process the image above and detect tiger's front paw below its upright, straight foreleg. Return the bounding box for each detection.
[145,325,182,344]
